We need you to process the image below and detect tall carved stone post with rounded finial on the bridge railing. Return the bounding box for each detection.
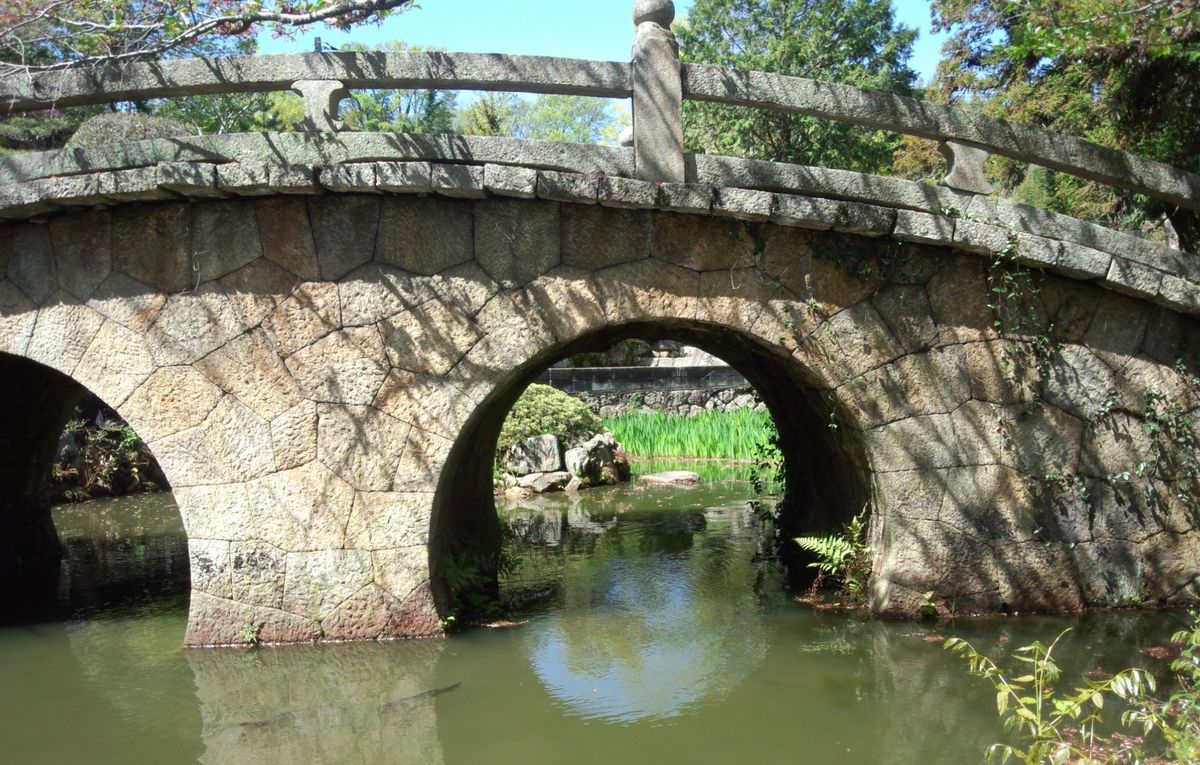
[632,0,685,183]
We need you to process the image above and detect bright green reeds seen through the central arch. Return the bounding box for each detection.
[604,408,775,460]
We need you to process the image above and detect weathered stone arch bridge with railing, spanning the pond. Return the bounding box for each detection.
[0,2,1200,645]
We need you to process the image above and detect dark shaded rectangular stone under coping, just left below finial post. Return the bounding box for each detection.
[562,205,654,271]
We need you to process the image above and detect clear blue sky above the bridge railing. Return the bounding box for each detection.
[260,0,944,82]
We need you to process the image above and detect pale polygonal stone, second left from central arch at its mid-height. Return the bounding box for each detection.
[317,404,410,492]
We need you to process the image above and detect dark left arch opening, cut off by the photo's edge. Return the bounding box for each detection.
[0,354,190,624]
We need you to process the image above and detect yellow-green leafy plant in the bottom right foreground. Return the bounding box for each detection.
[944,613,1200,765]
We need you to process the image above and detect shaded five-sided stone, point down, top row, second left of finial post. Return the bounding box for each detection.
[475,199,560,288]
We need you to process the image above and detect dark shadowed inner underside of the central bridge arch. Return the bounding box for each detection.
[430,319,870,615]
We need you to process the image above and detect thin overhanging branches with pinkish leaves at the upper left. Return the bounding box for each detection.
[0,0,413,76]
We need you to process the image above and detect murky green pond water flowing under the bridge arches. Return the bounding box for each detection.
[0,477,1186,765]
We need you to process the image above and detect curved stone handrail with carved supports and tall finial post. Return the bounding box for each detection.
[0,0,1200,211]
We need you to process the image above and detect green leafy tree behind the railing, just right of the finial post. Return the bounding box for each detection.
[676,0,917,173]
